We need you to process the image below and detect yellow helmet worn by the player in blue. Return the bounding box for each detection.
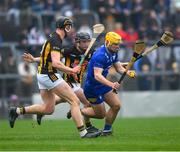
[105,32,122,46]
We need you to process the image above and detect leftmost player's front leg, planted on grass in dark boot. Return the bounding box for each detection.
[53,81,100,138]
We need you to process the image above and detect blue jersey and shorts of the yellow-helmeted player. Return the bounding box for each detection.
[84,45,118,104]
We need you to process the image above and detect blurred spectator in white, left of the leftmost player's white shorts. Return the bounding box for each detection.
[18,62,36,103]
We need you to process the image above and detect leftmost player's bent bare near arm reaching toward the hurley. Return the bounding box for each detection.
[51,51,80,74]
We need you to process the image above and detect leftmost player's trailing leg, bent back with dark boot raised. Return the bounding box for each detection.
[9,89,55,128]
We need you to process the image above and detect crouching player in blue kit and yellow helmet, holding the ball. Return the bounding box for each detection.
[81,32,135,135]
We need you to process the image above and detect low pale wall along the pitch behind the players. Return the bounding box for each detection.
[33,91,180,119]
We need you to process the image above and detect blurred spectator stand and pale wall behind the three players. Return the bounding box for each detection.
[0,0,180,118]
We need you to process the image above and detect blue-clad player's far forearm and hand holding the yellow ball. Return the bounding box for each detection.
[114,62,136,78]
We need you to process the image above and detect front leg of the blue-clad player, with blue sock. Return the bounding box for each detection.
[103,91,121,135]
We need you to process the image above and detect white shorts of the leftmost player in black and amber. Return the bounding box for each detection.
[37,73,64,90]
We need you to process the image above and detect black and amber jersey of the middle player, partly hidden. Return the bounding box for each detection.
[62,46,94,83]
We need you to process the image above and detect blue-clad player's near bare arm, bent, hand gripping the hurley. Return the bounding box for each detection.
[94,67,120,89]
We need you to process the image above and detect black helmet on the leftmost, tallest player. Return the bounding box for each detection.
[56,16,73,28]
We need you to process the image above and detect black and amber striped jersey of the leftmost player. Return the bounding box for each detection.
[38,32,62,74]
